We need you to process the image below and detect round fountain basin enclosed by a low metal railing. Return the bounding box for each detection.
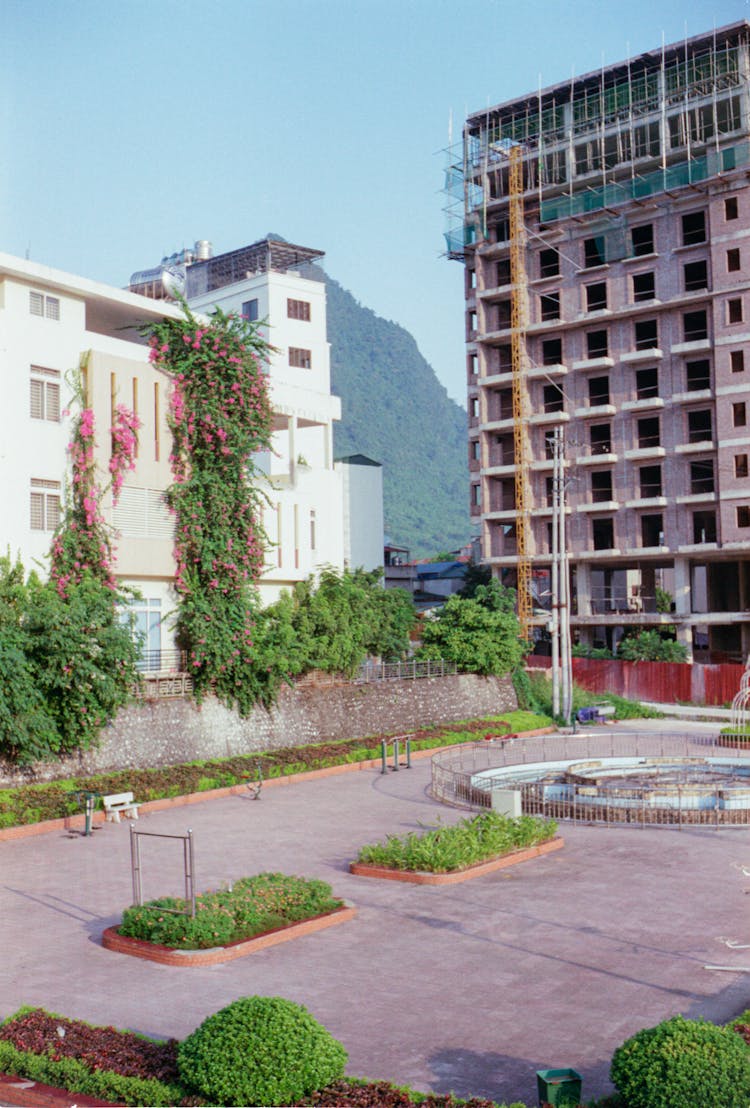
[432,731,750,828]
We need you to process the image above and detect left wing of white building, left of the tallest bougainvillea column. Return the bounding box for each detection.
[0,254,177,652]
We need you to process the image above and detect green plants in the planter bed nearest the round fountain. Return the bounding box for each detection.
[357,811,557,873]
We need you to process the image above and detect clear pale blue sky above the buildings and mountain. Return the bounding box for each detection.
[0,0,750,403]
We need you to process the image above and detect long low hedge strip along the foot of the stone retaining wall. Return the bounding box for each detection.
[0,711,552,828]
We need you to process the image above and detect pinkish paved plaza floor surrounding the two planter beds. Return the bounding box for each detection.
[0,721,750,1105]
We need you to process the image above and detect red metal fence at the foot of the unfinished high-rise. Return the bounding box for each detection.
[527,656,744,705]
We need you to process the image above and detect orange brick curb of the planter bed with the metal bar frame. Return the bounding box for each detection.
[102,904,357,966]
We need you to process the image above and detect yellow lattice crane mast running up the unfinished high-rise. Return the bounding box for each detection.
[507,146,532,638]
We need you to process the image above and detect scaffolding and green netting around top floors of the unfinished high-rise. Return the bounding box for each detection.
[444,21,750,251]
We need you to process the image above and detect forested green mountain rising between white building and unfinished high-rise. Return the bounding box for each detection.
[326,276,471,557]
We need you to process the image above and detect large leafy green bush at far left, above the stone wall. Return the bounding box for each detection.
[0,557,137,765]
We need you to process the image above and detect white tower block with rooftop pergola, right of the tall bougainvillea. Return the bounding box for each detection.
[178,238,345,603]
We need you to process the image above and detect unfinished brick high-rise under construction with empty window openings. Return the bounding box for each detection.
[445,21,750,661]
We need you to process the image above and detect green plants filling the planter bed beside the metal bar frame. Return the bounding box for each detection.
[120,873,341,951]
